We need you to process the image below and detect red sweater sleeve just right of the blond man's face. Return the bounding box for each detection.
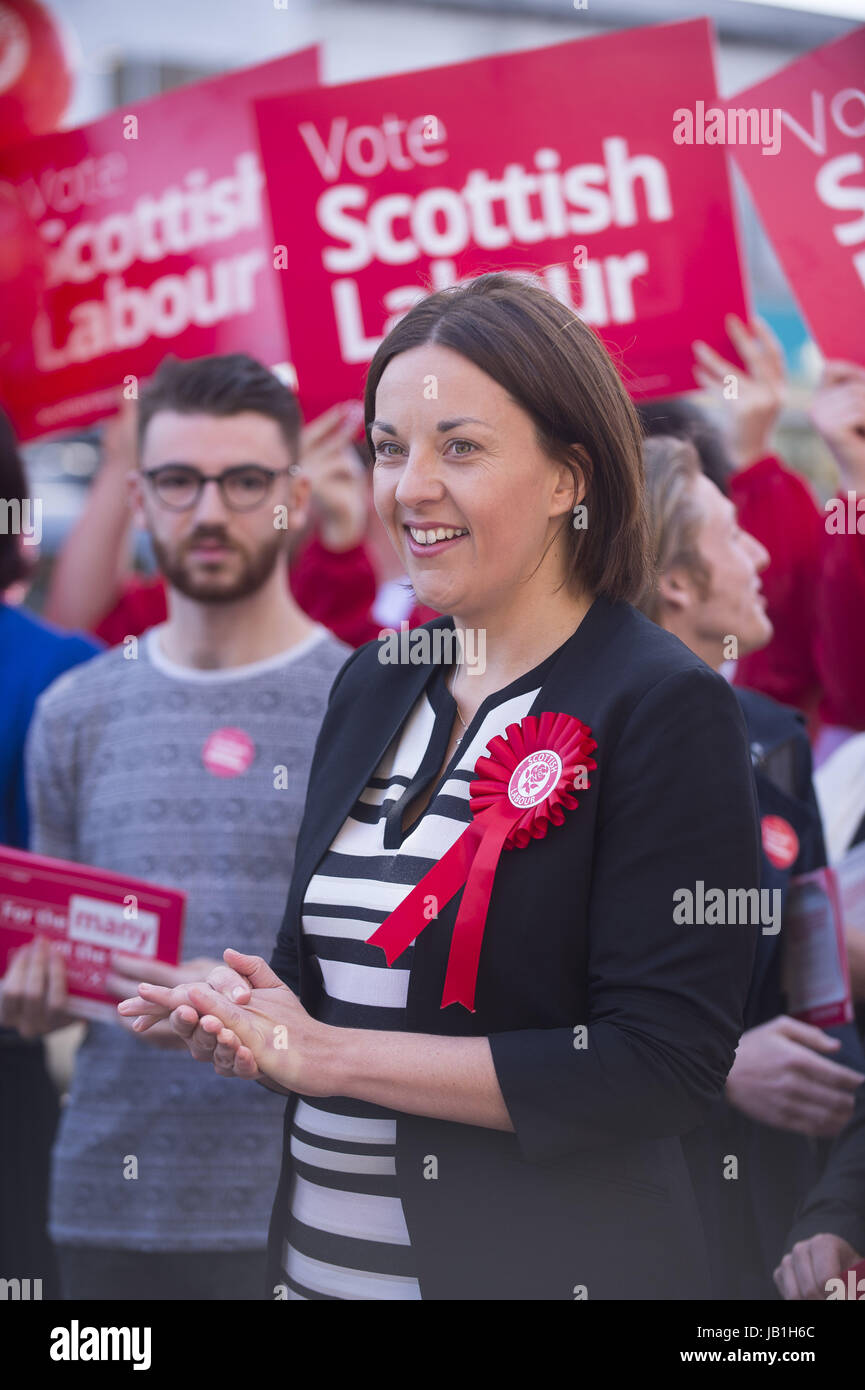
[730,456,822,713]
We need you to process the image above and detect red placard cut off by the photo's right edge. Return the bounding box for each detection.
[727,28,865,363]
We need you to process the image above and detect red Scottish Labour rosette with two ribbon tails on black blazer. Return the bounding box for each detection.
[369,710,598,1013]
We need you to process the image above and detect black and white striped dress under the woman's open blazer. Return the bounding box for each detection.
[282,659,552,1300]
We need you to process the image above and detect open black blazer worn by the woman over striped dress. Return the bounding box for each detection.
[270,598,759,1300]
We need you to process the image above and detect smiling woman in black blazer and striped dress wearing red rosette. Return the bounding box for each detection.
[121,274,759,1300]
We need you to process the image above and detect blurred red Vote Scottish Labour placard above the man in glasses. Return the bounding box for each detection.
[0,47,318,439]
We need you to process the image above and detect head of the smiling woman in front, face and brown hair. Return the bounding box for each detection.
[364,275,647,625]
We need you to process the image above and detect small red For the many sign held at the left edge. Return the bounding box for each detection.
[0,845,186,1023]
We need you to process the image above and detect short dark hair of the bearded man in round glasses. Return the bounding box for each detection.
[138,352,303,463]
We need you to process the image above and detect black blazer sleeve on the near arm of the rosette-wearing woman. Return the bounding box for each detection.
[490,666,761,1162]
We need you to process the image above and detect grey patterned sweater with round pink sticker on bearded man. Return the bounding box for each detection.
[26,628,350,1251]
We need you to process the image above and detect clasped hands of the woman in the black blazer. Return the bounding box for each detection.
[117,948,331,1095]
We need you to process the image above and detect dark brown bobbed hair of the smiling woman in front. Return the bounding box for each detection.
[363,271,648,599]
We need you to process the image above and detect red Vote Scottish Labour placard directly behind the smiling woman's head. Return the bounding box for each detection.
[254,19,747,414]
